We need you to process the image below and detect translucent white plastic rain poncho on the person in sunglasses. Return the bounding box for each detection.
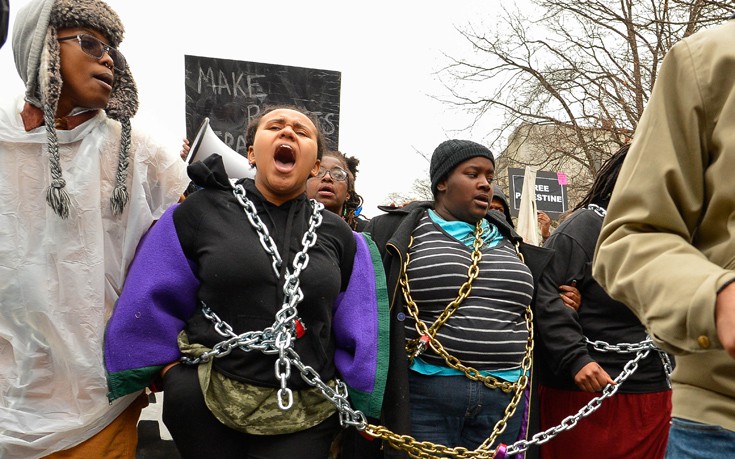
[0,99,193,459]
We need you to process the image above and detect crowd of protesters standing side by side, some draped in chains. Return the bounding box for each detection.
[0,0,735,459]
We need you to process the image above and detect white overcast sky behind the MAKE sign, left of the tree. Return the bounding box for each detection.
[0,0,513,216]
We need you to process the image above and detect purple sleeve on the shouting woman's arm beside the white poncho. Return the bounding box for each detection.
[105,206,199,373]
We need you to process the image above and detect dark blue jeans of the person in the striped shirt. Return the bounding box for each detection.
[408,370,524,450]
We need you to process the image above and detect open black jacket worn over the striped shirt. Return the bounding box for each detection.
[365,201,553,457]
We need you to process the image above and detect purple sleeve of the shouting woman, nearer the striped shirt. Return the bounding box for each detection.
[332,234,378,393]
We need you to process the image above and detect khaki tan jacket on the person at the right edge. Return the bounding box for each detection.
[593,20,735,431]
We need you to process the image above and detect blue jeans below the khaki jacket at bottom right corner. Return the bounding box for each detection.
[666,418,735,459]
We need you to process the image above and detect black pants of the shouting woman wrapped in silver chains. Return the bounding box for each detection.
[163,365,339,459]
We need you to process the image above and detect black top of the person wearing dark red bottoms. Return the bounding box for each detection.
[536,209,668,393]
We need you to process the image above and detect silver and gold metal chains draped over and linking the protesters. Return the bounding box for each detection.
[182,195,671,459]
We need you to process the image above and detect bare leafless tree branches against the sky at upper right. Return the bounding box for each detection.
[436,0,732,208]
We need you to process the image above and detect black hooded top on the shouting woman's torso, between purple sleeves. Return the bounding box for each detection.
[173,155,356,389]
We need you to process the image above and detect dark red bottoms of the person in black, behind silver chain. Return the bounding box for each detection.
[539,386,671,459]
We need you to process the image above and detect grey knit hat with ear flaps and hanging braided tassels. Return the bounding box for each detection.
[13,0,138,218]
